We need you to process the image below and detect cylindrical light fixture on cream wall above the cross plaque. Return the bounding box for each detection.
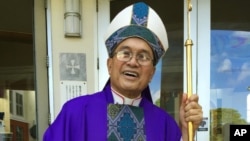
[64,0,81,37]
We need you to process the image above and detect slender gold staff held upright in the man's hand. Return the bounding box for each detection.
[185,0,194,141]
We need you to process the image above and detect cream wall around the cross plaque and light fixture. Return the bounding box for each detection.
[48,0,98,117]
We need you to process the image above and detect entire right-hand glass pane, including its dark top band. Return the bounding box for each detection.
[210,0,250,141]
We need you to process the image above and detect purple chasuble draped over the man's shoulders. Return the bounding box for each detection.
[43,81,181,141]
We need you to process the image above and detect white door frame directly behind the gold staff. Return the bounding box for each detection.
[183,0,211,141]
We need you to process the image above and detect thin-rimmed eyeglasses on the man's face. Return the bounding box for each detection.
[114,50,153,66]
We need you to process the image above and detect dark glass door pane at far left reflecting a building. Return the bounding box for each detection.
[0,0,36,141]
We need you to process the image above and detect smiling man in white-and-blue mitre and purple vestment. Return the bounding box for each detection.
[44,2,202,141]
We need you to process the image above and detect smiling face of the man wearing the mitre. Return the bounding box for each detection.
[107,38,155,98]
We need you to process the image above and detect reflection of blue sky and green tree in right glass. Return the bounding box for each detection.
[210,30,250,140]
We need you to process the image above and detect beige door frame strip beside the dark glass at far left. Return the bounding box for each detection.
[34,0,49,140]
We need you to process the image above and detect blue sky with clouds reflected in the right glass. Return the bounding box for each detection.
[210,30,250,119]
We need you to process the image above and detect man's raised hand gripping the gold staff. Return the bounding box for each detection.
[180,94,203,141]
